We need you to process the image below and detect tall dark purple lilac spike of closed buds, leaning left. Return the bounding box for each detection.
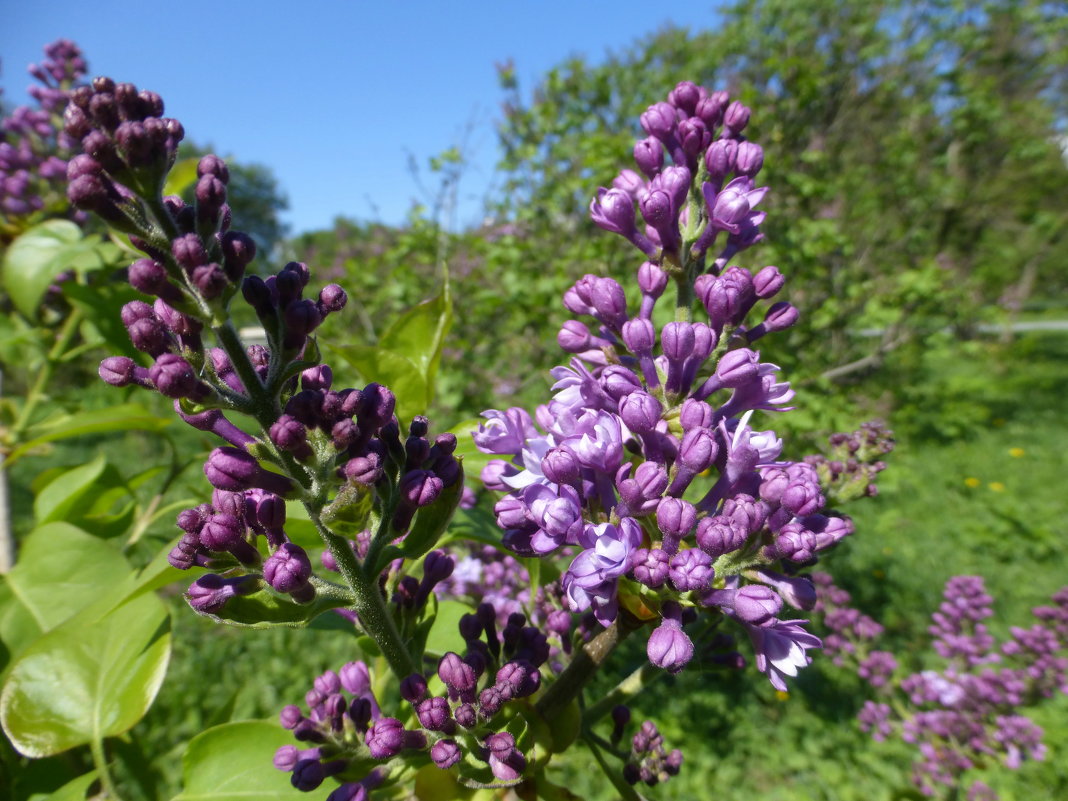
[64,78,462,614]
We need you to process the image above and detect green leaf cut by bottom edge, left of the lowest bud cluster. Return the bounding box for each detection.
[173,720,308,801]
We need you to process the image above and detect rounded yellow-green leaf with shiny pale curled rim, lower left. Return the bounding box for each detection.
[0,595,171,758]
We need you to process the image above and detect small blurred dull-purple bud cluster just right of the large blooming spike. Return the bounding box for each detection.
[804,421,894,504]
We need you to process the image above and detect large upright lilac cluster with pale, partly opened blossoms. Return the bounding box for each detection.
[473,82,852,689]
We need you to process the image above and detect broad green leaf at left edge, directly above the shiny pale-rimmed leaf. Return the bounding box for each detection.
[0,522,130,666]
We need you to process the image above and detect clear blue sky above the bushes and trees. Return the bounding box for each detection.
[0,0,717,233]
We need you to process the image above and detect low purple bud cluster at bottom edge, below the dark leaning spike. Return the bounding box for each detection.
[274,598,549,801]
